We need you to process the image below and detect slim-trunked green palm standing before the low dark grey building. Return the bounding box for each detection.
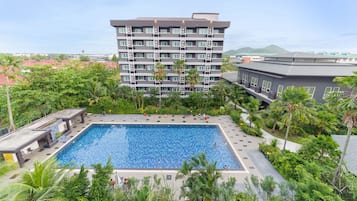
[281,87,310,151]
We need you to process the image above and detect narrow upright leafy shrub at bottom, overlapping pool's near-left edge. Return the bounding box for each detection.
[88,159,114,201]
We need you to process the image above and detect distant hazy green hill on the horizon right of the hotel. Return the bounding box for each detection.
[223,45,289,56]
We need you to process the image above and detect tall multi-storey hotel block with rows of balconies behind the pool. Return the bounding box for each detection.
[110,13,230,96]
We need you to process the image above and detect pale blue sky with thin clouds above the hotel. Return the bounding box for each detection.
[0,0,357,53]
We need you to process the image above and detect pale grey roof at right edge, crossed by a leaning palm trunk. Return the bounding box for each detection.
[332,135,357,175]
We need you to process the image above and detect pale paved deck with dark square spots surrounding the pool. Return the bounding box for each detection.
[0,114,283,190]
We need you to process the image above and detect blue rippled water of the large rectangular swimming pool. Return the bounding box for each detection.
[57,124,242,170]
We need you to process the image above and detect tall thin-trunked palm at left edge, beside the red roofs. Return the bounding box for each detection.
[0,55,20,131]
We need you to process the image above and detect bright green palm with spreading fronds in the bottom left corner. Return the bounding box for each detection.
[4,158,68,201]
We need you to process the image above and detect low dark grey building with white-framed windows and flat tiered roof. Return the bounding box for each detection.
[238,53,357,104]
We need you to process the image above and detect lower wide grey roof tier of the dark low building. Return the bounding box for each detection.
[238,61,357,77]
